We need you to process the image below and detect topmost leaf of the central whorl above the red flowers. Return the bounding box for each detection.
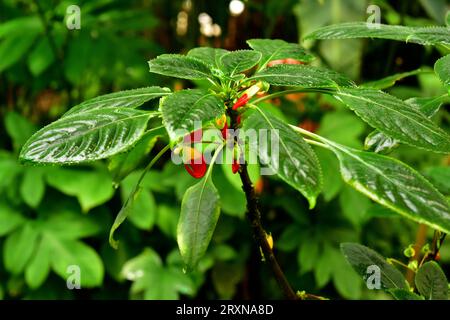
[247,39,314,69]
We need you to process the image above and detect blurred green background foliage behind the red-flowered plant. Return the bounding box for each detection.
[0,0,450,299]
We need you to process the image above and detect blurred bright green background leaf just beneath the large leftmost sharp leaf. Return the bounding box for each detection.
[47,168,114,212]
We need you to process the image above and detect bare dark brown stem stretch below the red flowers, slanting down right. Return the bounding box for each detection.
[239,163,298,300]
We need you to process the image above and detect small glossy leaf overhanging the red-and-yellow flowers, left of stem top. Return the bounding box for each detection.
[160,89,225,141]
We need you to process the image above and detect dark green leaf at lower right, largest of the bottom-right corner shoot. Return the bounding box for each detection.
[341,243,408,290]
